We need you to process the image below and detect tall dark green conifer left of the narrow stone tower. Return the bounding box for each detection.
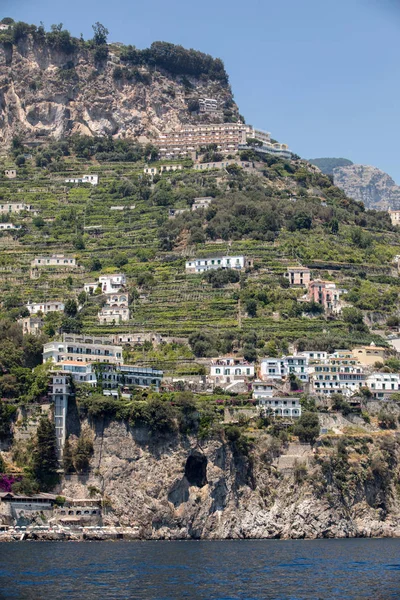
[33,417,59,488]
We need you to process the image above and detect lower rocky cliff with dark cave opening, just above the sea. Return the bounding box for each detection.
[60,421,400,539]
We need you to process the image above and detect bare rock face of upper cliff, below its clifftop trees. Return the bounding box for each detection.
[0,36,238,143]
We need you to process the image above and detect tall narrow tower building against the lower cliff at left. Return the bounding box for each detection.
[49,370,72,460]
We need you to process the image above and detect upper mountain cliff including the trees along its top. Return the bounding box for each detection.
[0,23,238,143]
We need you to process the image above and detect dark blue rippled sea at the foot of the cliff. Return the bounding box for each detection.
[0,539,400,600]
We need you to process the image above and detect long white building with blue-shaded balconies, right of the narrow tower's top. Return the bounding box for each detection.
[98,365,163,390]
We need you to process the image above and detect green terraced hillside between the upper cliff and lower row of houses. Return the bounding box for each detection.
[0,138,400,370]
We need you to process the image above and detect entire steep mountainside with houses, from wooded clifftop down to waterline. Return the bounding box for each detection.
[0,24,400,539]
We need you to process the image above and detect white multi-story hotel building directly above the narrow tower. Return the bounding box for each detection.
[43,333,123,365]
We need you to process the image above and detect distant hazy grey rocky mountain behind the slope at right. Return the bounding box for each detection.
[333,165,400,210]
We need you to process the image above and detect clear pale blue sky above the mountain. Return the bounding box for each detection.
[0,0,400,184]
